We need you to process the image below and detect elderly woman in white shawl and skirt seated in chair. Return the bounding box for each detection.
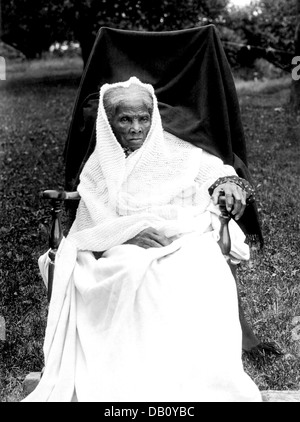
[26,77,261,402]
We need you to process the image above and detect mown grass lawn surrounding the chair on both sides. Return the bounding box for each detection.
[0,58,300,402]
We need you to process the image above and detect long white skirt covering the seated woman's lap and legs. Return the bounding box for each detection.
[25,229,261,402]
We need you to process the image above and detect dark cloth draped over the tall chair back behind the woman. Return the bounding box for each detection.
[64,25,262,242]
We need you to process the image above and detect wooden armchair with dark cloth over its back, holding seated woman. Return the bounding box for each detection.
[25,25,281,400]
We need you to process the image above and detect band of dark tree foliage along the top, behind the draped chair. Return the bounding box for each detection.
[2,0,296,71]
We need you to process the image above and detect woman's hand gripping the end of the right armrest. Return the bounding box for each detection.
[211,182,246,220]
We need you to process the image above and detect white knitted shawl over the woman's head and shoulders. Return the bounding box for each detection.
[68,77,235,251]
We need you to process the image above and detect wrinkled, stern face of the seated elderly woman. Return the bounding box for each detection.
[110,96,151,151]
